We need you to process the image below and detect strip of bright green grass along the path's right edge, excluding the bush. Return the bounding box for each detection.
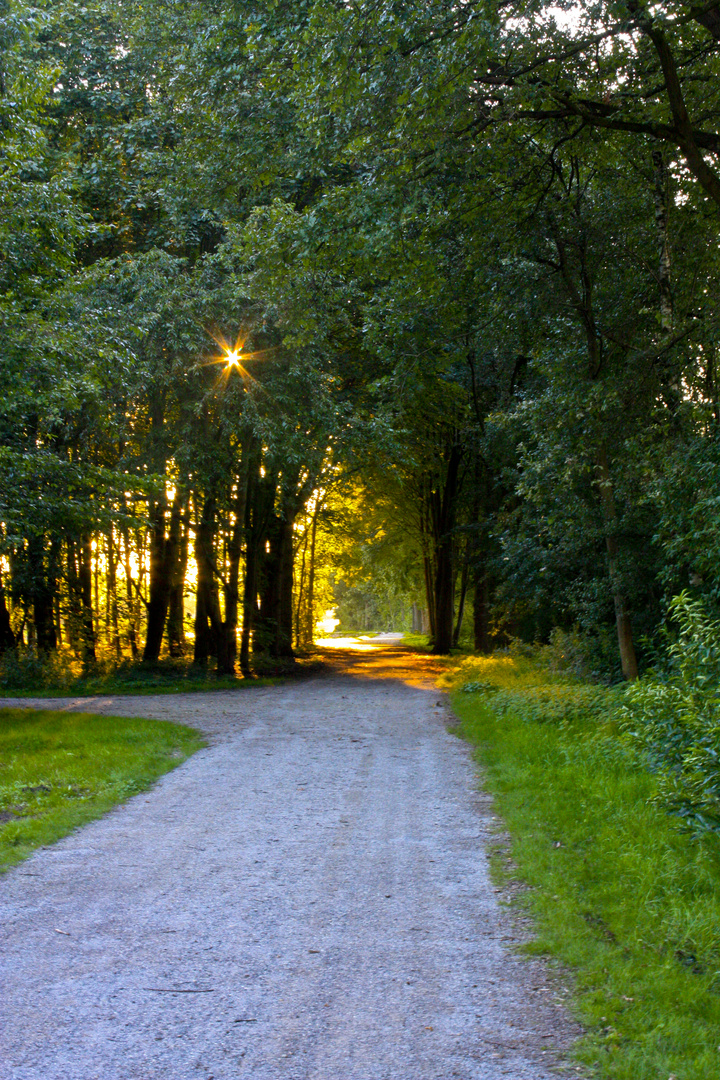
[446,658,720,1080]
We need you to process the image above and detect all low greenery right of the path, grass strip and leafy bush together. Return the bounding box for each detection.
[446,597,720,1080]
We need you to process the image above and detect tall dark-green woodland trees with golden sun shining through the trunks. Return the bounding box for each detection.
[0,0,720,679]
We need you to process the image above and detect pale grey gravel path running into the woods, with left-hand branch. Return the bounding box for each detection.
[0,643,576,1080]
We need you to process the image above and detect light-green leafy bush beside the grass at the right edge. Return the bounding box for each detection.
[623,593,720,833]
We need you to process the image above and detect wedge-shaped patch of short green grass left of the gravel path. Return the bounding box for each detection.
[0,708,204,873]
